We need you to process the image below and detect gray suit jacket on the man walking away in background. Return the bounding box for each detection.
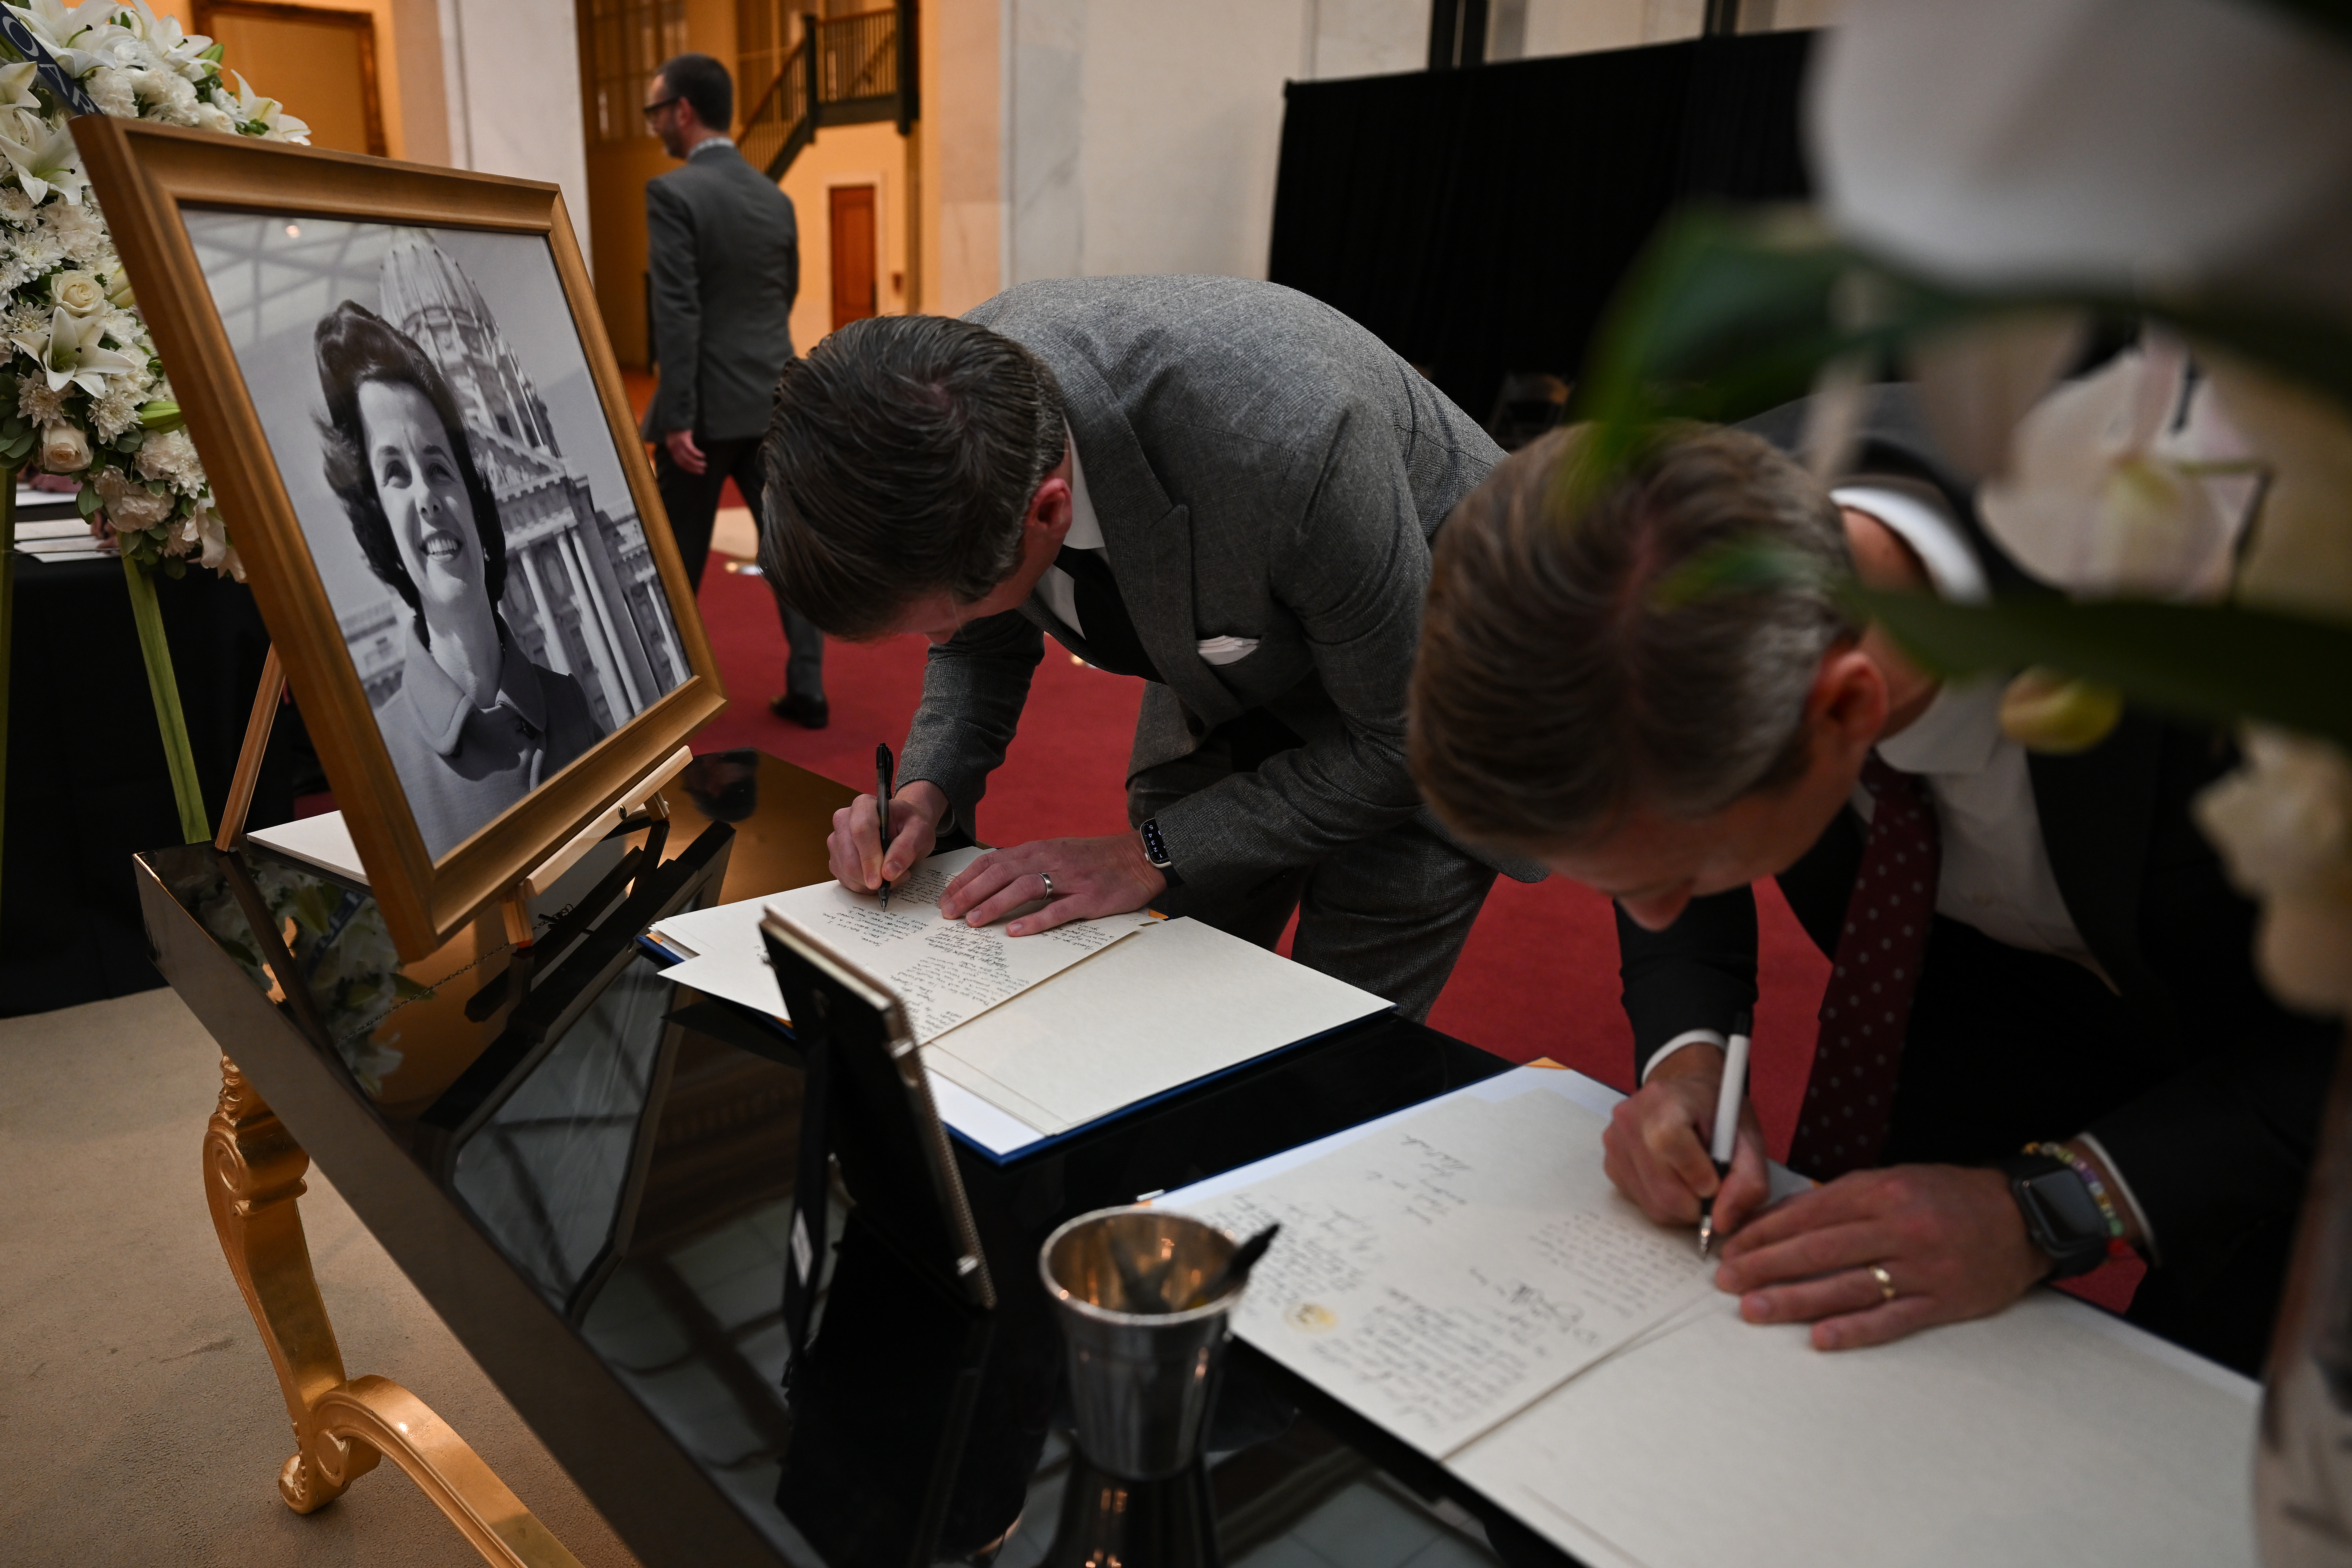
[644,146,800,442]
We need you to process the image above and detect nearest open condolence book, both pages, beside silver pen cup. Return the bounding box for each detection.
[1160,1067,2258,1568]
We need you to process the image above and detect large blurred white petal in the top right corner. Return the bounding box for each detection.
[1806,0,2352,315]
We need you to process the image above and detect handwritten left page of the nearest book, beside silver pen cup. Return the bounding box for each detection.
[1164,1091,1712,1458]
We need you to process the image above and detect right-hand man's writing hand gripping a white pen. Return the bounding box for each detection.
[1602,1044,1771,1237]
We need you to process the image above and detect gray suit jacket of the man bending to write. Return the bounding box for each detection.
[901,277,1541,896]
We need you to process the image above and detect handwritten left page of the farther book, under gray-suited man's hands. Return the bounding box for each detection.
[651,849,1150,1044]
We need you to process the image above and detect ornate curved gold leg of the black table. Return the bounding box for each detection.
[205,1055,579,1568]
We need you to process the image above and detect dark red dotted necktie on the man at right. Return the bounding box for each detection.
[1787,752,1940,1180]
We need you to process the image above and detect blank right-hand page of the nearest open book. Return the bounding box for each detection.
[1449,1291,2258,1568]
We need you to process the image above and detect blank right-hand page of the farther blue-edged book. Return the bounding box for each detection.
[922,919,1390,1133]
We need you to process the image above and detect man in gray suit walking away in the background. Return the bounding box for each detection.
[644,54,828,729]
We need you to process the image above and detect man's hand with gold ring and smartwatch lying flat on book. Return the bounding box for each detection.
[1715,1166,2051,1349]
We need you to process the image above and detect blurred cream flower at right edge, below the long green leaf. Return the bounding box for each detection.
[2197,729,2352,1013]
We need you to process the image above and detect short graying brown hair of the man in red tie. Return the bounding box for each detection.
[1409,425,1860,853]
